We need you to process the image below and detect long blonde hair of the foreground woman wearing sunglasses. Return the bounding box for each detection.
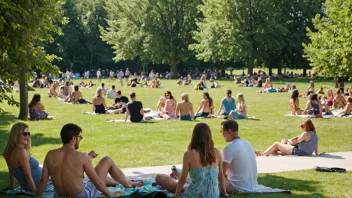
[4,122,31,159]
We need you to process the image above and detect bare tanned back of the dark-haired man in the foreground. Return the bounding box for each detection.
[45,147,91,197]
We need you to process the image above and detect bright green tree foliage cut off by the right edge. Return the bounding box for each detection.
[303,0,352,77]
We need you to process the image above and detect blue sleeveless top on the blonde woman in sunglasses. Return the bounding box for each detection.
[10,156,42,190]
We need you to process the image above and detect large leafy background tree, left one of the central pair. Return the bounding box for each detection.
[102,0,201,76]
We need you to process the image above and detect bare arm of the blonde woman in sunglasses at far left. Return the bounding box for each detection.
[17,149,37,194]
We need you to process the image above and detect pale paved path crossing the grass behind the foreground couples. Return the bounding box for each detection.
[122,152,352,181]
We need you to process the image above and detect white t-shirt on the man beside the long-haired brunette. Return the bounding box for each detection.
[223,139,258,192]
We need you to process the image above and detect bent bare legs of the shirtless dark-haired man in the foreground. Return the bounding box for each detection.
[95,157,143,188]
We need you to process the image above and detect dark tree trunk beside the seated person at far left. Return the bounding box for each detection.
[18,69,28,120]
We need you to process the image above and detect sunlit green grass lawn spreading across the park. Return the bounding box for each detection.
[0,79,352,197]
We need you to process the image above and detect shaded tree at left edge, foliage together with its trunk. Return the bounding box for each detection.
[0,0,62,120]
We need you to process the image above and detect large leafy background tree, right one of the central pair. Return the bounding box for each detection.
[190,0,287,74]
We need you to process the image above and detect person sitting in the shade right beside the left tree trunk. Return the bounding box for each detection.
[28,94,49,120]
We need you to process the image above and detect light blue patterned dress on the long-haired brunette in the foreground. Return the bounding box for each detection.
[183,166,220,198]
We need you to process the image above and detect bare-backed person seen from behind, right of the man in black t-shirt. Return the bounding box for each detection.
[176,93,196,120]
